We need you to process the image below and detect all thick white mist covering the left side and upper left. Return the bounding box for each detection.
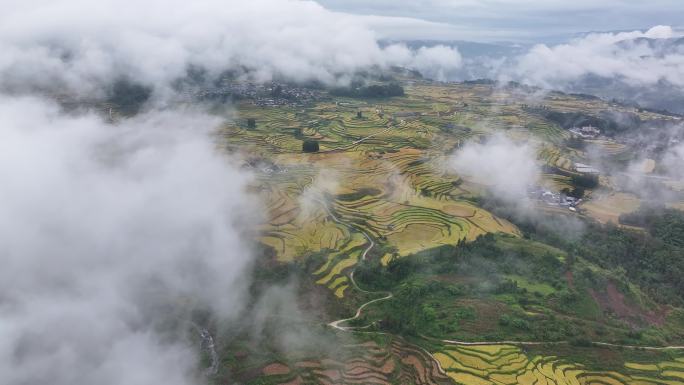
[0,0,470,385]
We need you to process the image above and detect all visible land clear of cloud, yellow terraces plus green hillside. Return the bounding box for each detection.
[219,79,684,385]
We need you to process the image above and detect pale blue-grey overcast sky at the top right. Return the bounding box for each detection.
[317,0,684,41]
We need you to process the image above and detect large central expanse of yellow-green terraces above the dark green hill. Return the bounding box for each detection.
[220,82,680,297]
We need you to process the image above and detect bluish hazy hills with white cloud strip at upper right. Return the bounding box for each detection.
[390,27,684,113]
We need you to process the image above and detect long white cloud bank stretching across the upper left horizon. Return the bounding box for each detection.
[0,0,459,95]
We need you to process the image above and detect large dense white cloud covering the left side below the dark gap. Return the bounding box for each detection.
[0,96,255,385]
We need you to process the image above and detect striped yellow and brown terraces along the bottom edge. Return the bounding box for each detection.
[248,337,684,385]
